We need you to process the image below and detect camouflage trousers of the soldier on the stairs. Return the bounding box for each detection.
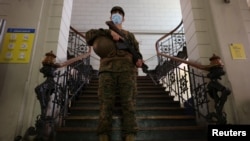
[97,72,138,135]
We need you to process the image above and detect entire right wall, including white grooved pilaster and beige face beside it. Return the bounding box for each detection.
[181,0,250,124]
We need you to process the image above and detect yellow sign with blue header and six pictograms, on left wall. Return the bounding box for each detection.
[0,28,35,63]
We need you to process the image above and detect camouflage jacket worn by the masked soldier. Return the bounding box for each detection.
[86,29,141,72]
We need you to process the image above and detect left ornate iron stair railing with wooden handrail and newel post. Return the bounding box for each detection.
[15,27,94,141]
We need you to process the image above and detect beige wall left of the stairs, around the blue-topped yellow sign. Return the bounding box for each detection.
[0,0,72,141]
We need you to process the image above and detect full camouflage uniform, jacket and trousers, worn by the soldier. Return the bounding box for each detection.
[86,29,140,135]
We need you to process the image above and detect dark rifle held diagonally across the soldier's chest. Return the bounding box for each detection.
[106,21,148,73]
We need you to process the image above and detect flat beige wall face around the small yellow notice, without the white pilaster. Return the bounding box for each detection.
[210,0,250,124]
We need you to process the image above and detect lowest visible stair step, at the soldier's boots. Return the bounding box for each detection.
[56,126,206,141]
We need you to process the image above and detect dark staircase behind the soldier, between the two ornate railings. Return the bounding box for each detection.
[55,76,206,141]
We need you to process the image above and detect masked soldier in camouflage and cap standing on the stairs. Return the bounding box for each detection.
[86,6,143,141]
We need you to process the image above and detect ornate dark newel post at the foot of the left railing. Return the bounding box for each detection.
[35,51,58,140]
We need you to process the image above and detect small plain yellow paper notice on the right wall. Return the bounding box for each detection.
[230,43,246,59]
